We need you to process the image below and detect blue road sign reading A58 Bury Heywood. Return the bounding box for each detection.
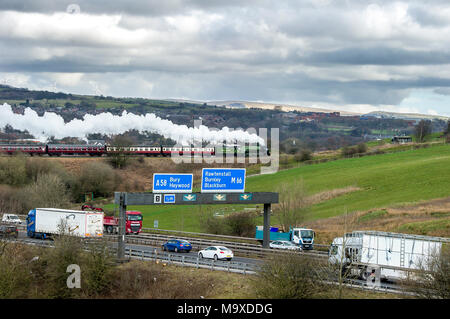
[153,173,192,193]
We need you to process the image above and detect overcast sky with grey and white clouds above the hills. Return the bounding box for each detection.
[0,0,450,116]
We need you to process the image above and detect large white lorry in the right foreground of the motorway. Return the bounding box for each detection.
[328,231,450,281]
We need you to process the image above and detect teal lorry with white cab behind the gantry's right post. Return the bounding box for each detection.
[255,226,315,250]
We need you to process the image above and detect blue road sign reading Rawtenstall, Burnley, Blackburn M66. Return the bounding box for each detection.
[201,168,245,193]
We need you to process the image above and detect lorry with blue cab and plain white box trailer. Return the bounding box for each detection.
[27,208,103,238]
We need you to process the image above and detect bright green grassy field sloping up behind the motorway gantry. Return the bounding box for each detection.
[106,145,450,232]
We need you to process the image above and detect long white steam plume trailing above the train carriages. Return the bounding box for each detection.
[0,103,264,145]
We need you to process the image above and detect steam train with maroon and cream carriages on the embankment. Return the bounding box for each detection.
[0,144,270,157]
